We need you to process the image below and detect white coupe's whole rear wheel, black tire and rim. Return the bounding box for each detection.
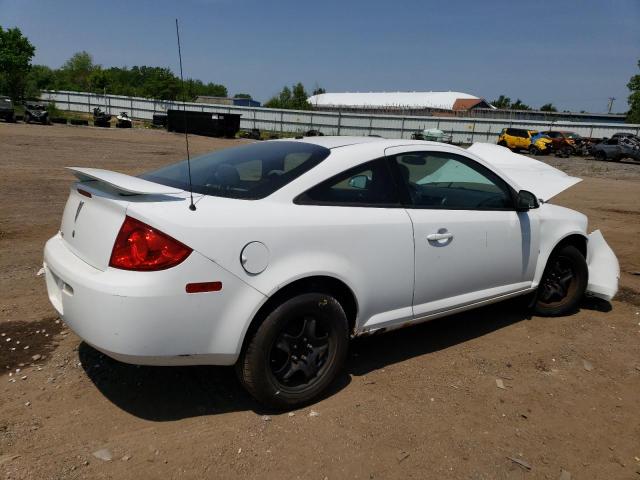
[236,293,349,409]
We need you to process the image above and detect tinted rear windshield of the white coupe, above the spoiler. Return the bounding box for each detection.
[140,141,330,200]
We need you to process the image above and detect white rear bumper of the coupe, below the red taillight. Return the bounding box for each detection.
[44,235,264,365]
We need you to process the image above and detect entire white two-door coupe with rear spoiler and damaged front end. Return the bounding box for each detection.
[44,137,619,408]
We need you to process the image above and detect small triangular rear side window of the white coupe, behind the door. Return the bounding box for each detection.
[295,158,400,207]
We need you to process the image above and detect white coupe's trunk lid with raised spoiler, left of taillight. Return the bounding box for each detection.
[60,167,189,270]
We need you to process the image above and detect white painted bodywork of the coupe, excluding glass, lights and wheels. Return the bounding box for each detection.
[44,137,619,365]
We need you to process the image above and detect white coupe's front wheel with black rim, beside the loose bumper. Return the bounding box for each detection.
[534,245,589,317]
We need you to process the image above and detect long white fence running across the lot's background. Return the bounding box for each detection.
[41,91,640,143]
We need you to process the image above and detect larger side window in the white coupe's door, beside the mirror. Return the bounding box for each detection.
[394,152,513,210]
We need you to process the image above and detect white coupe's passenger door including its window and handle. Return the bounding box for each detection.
[385,147,538,319]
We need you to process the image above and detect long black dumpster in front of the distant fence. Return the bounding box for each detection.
[167,110,241,138]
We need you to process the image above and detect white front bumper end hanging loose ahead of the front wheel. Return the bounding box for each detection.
[587,230,620,300]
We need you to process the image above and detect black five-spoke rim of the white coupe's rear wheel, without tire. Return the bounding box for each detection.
[269,315,331,389]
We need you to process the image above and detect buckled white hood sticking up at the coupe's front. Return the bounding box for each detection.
[467,143,582,201]
